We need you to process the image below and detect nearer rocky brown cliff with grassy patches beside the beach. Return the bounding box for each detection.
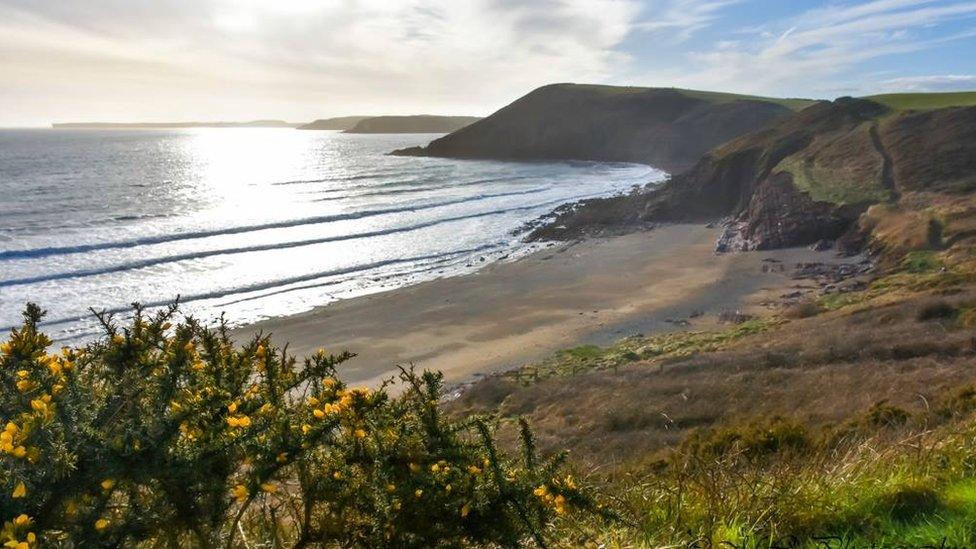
[531,98,976,251]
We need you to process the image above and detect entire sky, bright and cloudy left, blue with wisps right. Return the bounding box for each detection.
[0,0,976,127]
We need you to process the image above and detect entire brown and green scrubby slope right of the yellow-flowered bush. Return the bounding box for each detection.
[450,230,976,547]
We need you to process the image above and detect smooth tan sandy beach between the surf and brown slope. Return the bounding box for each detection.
[235,225,833,384]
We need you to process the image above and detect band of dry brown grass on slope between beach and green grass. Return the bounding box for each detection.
[452,290,976,470]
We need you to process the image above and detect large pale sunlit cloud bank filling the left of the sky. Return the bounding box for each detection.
[0,0,639,123]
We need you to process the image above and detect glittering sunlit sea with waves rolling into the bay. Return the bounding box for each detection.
[0,128,665,344]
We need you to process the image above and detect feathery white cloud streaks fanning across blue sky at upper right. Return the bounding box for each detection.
[659,0,976,97]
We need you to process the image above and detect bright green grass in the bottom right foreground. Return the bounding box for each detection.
[564,412,976,547]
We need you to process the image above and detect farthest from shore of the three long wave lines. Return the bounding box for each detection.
[0,188,547,261]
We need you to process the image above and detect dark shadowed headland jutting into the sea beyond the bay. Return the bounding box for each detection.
[394,84,792,172]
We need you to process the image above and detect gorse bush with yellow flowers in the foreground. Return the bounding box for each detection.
[0,304,596,549]
